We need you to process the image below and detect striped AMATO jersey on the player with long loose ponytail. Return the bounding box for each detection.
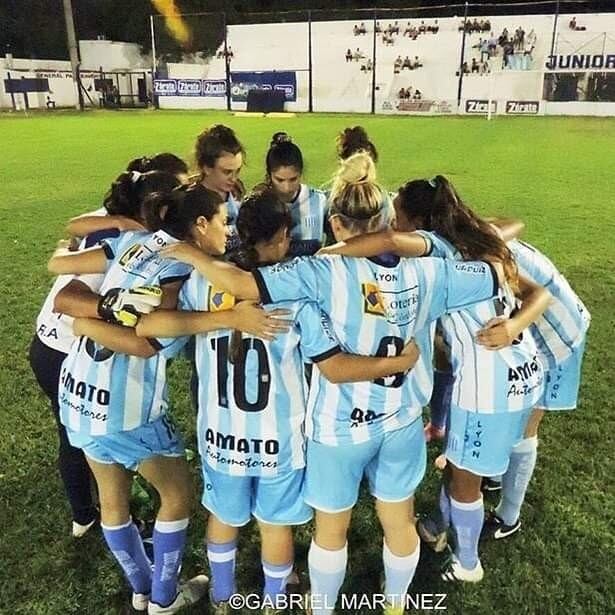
[421,232,544,414]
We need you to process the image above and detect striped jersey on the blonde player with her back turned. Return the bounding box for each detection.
[254,255,497,445]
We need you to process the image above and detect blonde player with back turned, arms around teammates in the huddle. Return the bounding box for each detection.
[159,152,501,615]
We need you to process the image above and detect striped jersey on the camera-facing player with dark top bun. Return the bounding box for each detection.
[288,184,327,257]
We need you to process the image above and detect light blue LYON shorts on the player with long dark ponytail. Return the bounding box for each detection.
[445,404,532,476]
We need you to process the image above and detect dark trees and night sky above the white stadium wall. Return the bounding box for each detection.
[0,0,615,59]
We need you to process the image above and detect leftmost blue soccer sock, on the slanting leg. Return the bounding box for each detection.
[102,521,152,594]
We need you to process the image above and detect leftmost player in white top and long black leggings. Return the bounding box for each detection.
[29,166,183,538]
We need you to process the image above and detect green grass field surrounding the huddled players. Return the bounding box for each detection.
[0,112,615,615]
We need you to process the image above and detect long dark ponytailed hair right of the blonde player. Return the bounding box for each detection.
[399,175,517,288]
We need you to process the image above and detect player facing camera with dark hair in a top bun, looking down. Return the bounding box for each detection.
[265,132,327,256]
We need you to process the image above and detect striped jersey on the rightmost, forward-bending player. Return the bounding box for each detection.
[508,240,591,369]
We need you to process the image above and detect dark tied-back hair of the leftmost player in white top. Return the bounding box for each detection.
[103,171,180,220]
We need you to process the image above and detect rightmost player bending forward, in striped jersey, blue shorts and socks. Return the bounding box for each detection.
[483,241,591,540]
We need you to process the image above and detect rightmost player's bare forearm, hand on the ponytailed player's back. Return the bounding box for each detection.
[476,276,551,350]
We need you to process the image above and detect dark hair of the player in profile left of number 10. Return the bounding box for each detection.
[143,184,224,239]
